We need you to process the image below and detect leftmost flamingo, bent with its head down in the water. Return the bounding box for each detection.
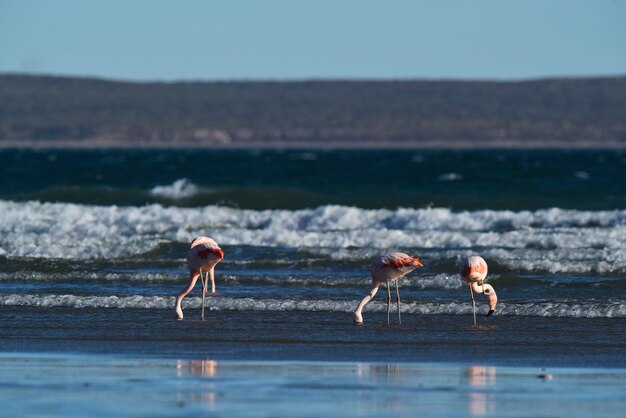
[176,237,224,319]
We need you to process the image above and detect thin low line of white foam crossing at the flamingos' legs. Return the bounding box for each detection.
[0,294,626,318]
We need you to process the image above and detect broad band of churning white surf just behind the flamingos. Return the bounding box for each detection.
[0,201,626,273]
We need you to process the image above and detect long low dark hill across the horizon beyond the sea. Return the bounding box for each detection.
[0,75,626,147]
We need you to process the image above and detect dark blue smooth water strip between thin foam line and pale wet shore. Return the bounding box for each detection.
[0,303,626,368]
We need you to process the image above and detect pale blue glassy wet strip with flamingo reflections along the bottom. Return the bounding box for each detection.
[0,354,626,417]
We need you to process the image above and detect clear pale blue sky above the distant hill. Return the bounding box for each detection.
[0,0,626,80]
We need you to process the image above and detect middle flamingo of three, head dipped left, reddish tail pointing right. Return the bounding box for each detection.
[353,253,424,324]
